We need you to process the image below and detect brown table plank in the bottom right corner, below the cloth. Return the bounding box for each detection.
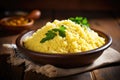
[94,66,120,80]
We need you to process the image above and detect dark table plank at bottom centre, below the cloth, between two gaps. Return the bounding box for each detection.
[24,71,91,80]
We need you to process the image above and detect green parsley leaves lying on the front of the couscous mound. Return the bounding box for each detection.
[40,25,66,43]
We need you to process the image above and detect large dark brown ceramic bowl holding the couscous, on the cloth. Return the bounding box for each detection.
[16,30,112,68]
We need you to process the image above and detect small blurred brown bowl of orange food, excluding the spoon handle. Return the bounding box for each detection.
[0,17,34,32]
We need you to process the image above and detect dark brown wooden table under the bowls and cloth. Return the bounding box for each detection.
[0,11,120,80]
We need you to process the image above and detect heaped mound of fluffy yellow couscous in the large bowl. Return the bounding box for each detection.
[24,20,105,54]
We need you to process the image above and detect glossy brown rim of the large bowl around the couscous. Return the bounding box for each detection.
[16,28,112,57]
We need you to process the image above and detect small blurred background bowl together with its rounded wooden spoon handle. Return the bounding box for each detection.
[0,10,41,33]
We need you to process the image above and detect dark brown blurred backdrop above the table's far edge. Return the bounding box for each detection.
[0,0,120,17]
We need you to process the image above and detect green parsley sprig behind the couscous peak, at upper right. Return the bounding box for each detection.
[69,17,89,27]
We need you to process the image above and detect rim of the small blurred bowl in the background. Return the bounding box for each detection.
[0,16,34,27]
